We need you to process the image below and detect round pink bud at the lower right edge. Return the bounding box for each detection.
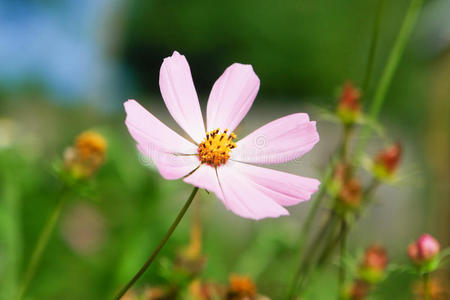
[408,234,440,265]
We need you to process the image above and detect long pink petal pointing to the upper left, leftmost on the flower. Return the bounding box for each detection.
[124,100,197,154]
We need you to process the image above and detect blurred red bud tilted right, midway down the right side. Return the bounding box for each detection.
[374,143,402,179]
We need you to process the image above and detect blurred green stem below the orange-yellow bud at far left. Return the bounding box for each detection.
[17,188,67,300]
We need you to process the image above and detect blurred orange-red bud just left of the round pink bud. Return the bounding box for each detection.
[360,245,388,284]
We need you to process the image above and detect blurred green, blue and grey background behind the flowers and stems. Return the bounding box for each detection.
[0,0,450,299]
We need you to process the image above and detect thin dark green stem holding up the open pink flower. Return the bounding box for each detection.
[114,187,198,300]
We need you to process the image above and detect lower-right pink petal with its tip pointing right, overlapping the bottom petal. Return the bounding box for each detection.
[227,161,320,206]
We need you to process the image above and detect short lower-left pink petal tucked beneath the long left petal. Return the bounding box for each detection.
[137,144,200,180]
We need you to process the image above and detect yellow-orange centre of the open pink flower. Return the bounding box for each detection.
[198,129,236,167]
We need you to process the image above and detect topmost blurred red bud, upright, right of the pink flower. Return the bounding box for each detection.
[337,82,361,124]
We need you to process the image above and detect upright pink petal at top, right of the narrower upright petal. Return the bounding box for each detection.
[206,63,259,132]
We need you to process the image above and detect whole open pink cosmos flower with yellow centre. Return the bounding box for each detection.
[124,51,320,219]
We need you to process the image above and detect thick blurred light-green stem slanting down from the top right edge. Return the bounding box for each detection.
[355,0,423,164]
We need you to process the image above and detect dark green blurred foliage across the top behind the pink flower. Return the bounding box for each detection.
[119,0,429,132]
